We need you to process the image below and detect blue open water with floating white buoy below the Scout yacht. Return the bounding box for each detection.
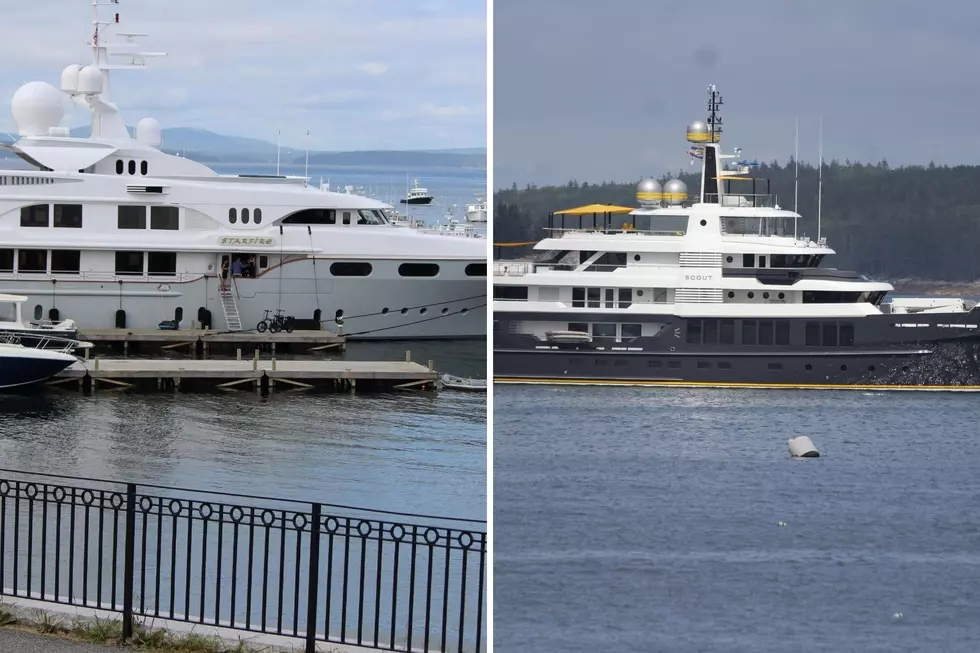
[494,386,980,653]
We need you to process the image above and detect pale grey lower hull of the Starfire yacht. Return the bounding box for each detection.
[0,259,486,339]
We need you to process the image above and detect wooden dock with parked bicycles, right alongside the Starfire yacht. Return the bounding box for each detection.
[78,329,347,358]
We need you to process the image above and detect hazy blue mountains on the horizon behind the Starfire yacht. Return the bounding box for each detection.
[57,126,487,169]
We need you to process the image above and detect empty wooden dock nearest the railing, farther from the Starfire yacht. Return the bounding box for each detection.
[48,356,438,393]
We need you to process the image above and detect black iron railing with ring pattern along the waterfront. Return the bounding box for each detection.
[0,470,487,653]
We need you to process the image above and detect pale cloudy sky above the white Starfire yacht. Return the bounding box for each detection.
[0,0,486,150]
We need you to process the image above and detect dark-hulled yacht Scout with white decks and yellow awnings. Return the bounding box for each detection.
[493,86,980,390]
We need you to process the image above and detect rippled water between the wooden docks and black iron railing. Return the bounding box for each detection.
[0,341,487,519]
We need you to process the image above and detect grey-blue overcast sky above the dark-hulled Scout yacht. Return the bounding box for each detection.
[493,0,980,188]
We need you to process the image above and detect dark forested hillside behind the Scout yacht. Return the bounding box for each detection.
[493,161,980,282]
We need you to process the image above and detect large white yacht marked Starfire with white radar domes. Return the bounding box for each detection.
[0,0,487,338]
